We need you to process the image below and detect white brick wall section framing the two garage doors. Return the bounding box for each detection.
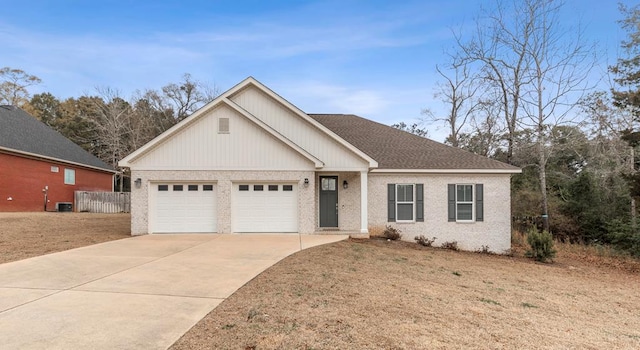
[131,170,316,235]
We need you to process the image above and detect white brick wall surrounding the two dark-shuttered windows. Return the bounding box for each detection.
[369,173,511,253]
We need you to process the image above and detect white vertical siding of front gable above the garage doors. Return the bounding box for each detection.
[134,105,315,171]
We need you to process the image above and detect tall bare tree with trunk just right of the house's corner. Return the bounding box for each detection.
[521,0,595,230]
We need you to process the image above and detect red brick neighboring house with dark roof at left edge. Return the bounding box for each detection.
[0,106,115,212]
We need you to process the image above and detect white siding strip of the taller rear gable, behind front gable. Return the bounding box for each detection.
[230,86,368,171]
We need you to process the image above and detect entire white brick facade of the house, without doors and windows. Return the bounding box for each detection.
[131,171,511,253]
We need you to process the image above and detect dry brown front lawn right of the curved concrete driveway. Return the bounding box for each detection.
[171,239,640,350]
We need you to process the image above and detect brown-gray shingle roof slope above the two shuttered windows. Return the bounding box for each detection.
[309,114,518,171]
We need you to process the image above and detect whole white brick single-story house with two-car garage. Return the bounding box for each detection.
[119,77,520,252]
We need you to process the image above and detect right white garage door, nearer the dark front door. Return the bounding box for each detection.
[231,183,298,232]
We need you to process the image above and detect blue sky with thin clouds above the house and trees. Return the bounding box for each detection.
[0,0,633,141]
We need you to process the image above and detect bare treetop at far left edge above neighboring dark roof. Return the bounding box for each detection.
[0,67,42,107]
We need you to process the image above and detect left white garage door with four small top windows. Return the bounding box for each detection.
[151,183,217,233]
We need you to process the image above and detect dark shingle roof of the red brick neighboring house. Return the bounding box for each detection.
[0,106,115,172]
